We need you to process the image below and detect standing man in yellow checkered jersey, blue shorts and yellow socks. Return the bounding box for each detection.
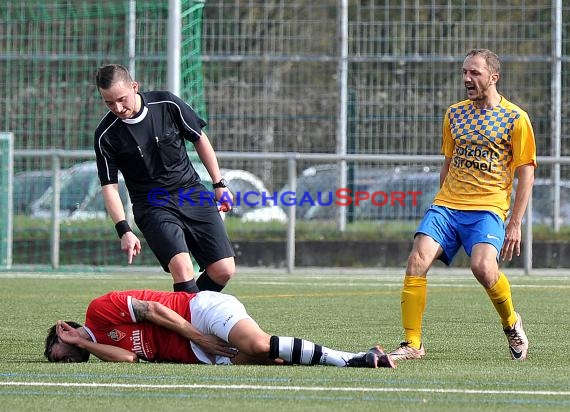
[390,49,536,360]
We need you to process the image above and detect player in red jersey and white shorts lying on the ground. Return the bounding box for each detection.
[44,290,395,368]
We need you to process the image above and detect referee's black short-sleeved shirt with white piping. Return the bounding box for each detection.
[94,91,206,203]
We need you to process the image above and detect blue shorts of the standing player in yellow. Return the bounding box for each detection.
[416,205,505,265]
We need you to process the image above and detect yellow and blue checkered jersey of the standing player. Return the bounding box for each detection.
[434,97,536,220]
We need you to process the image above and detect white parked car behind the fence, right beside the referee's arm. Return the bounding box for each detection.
[220,169,287,223]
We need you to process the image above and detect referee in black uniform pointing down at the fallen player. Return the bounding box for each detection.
[94,64,235,292]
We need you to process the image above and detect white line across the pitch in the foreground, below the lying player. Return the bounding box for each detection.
[0,381,570,396]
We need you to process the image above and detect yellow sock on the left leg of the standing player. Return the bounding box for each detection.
[401,276,427,349]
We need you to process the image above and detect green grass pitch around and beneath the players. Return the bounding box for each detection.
[0,269,570,412]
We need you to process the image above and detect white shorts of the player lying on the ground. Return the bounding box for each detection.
[190,290,253,365]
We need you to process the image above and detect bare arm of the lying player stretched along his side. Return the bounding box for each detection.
[131,298,237,357]
